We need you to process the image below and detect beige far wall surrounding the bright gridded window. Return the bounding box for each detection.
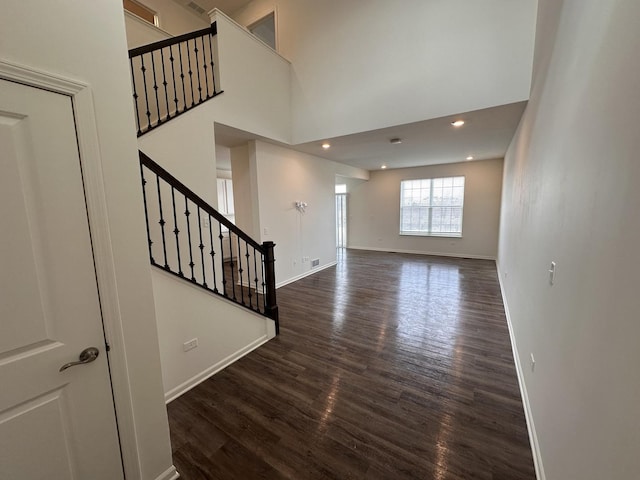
[347,159,502,258]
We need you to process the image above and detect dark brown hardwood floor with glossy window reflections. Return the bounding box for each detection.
[168,250,535,480]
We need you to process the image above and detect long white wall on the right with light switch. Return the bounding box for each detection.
[499,0,640,480]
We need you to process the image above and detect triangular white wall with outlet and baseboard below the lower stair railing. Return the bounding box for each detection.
[152,269,275,401]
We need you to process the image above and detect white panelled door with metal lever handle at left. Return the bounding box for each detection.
[0,80,123,480]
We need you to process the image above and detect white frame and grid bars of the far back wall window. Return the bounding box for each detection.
[400,175,466,238]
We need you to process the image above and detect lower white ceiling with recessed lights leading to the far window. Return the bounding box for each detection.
[215,102,526,170]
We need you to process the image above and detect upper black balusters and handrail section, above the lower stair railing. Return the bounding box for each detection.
[129,22,222,136]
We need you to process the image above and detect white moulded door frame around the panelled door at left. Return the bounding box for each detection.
[0,59,142,478]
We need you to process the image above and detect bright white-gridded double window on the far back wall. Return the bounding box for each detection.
[400,177,464,237]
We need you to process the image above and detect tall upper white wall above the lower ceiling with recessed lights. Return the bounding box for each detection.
[233,0,537,143]
